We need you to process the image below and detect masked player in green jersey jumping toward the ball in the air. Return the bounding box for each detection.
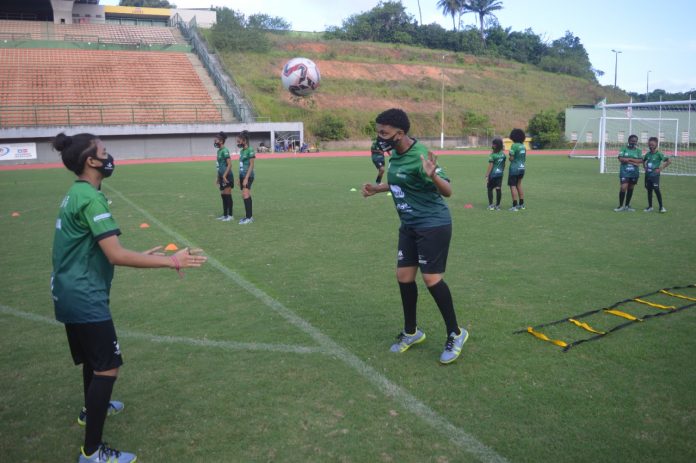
[362,109,469,364]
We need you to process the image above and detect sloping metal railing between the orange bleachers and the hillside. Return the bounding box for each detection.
[172,14,256,122]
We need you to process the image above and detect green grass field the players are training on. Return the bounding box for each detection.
[0,155,696,463]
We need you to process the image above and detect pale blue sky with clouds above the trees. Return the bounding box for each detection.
[101,0,696,95]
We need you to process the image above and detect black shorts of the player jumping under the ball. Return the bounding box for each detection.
[396,224,452,273]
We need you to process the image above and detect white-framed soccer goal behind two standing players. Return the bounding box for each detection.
[597,100,696,176]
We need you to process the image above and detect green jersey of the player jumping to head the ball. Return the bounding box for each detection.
[387,141,452,228]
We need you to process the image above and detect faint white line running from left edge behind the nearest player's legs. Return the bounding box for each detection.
[0,304,323,354]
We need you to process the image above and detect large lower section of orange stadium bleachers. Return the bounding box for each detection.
[0,48,222,126]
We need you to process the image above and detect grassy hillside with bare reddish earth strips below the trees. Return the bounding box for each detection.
[221,35,627,138]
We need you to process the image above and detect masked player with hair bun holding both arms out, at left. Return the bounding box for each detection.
[51,133,206,463]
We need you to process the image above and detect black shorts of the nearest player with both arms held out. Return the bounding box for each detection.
[65,320,123,371]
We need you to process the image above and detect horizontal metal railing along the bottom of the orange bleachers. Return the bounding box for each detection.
[0,103,225,127]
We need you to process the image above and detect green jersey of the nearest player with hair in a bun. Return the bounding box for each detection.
[51,180,121,323]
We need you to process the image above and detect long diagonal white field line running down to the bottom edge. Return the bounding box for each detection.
[104,185,507,463]
